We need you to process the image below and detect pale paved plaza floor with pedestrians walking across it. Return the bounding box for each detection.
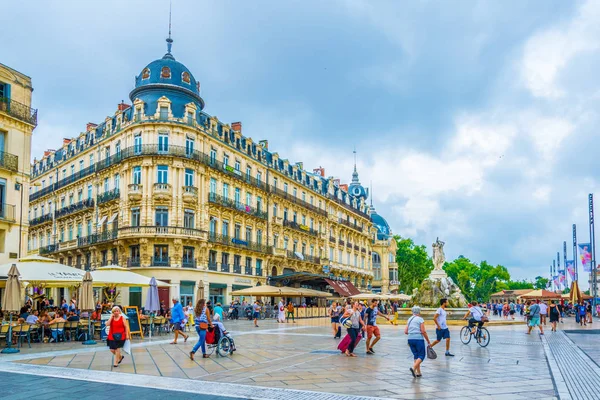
[0,319,600,400]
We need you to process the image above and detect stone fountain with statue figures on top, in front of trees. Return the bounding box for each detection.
[411,238,468,308]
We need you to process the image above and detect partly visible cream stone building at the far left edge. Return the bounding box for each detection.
[0,64,37,264]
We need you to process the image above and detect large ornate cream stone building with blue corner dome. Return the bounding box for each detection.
[29,38,394,303]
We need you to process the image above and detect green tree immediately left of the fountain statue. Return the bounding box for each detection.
[394,235,433,294]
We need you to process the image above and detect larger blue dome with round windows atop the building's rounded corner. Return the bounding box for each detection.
[129,47,204,118]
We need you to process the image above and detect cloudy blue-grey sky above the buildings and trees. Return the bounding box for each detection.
[0,0,600,286]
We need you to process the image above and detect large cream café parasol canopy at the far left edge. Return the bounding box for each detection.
[0,255,84,287]
